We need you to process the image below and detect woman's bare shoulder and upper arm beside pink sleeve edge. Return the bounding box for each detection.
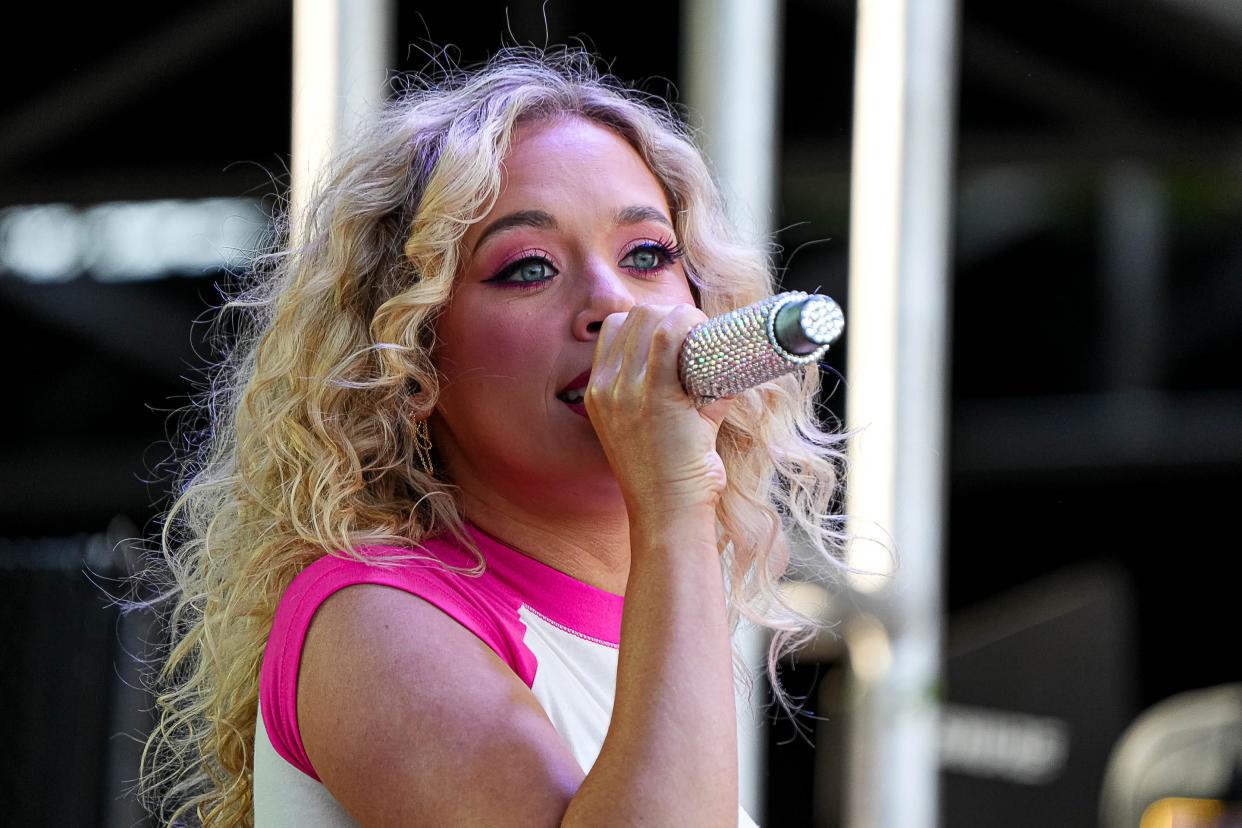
[297,585,584,826]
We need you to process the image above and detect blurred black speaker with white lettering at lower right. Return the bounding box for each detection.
[940,566,1136,828]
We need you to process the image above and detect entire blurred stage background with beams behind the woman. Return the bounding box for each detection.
[0,0,1242,828]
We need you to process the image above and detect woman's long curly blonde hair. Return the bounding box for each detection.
[139,48,846,826]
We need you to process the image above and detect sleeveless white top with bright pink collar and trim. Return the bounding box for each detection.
[253,524,755,828]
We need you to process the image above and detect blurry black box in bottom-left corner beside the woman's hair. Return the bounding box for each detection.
[0,521,150,828]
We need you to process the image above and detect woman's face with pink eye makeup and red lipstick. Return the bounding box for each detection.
[431,118,694,511]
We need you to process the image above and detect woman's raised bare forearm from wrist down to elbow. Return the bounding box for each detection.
[563,508,738,826]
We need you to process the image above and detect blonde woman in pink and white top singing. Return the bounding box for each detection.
[143,50,841,826]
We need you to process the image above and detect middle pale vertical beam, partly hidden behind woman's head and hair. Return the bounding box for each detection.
[682,0,781,821]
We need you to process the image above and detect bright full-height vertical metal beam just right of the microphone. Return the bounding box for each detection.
[846,0,956,828]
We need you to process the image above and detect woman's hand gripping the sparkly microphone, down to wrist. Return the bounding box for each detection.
[584,304,733,518]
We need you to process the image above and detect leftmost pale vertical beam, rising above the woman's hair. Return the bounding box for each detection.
[289,0,396,227]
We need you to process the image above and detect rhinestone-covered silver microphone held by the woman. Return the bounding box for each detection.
[678,290,846,408]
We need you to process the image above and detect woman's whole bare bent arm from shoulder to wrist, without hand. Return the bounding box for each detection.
[298,510,738,826]
